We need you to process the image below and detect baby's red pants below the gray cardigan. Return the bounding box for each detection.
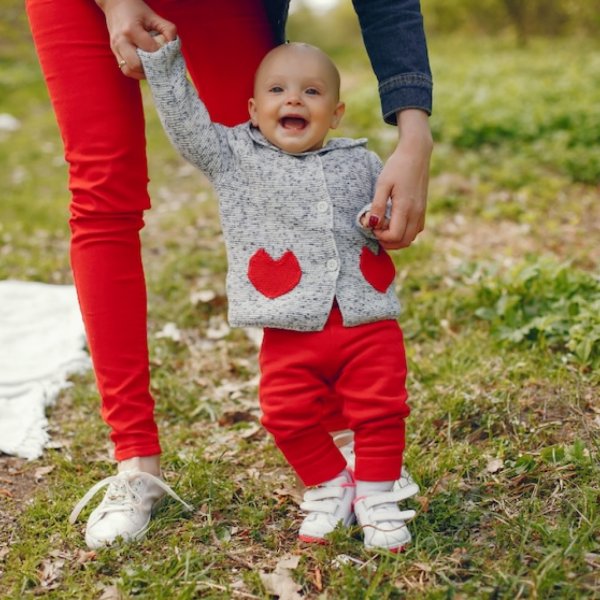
[260,307,410,485]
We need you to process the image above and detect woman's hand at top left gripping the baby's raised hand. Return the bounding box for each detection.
[96,0,177,79]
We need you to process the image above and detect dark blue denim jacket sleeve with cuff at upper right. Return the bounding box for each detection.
[352,0,433,124]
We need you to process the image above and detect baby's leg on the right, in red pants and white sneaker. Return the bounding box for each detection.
[335,321,418,551]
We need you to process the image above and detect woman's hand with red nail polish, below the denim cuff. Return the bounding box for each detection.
[369,109,433,250]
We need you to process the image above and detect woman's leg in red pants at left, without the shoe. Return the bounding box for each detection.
[27,0,160,460]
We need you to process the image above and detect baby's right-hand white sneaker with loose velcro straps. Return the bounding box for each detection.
[354,486,416,552]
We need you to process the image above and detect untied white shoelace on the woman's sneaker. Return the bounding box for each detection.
[69,471,193,524]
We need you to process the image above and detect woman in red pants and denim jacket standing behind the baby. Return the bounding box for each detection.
[26,0,432,547]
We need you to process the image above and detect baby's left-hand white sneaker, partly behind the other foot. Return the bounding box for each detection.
[298,470,356,544]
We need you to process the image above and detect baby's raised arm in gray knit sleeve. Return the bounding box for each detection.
[138,35,230,178]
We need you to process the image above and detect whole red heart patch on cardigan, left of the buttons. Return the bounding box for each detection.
[248,248,302,298]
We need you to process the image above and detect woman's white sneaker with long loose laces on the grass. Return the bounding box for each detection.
[69,469,192,550]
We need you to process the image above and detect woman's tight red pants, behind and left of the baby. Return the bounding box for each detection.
[27,0,273,460]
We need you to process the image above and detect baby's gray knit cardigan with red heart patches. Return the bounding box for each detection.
[138,40,399,331]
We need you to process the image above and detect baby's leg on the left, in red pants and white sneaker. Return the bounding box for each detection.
[260,329,354,542]
